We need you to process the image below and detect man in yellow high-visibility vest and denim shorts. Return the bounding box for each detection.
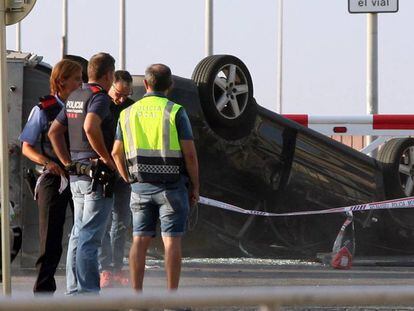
[112,64,199,291]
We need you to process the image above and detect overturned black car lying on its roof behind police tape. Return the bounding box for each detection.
[134,55,414,258]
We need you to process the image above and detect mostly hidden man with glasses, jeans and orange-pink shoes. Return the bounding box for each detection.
[99,70,134,288]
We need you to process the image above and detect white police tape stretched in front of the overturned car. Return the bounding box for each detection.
[198,196,414,217]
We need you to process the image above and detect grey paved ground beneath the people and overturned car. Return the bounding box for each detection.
[4,259,414,311]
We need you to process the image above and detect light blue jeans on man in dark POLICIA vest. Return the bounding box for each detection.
[66,180,113,294]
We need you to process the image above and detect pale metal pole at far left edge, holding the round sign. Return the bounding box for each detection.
[0,0,11,295]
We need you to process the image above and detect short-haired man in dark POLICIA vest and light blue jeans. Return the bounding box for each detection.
[49,53,116,294]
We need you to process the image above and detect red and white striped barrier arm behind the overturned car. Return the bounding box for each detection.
[283,114,414,136]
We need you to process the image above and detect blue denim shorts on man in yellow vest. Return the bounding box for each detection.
[131,184,190,237]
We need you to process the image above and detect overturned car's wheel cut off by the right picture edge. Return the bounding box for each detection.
[378,138,414,229]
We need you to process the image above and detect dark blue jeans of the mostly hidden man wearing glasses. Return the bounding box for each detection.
[99,177,131,272]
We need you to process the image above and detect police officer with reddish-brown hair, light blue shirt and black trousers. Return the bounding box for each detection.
[19,60,82,293]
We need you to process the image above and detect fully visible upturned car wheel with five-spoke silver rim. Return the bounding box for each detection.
[192,55,256,130]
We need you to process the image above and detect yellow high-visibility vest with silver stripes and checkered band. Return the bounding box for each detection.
[119,96,184,183]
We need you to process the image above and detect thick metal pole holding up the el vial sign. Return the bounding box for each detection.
[366,13,378,150]
